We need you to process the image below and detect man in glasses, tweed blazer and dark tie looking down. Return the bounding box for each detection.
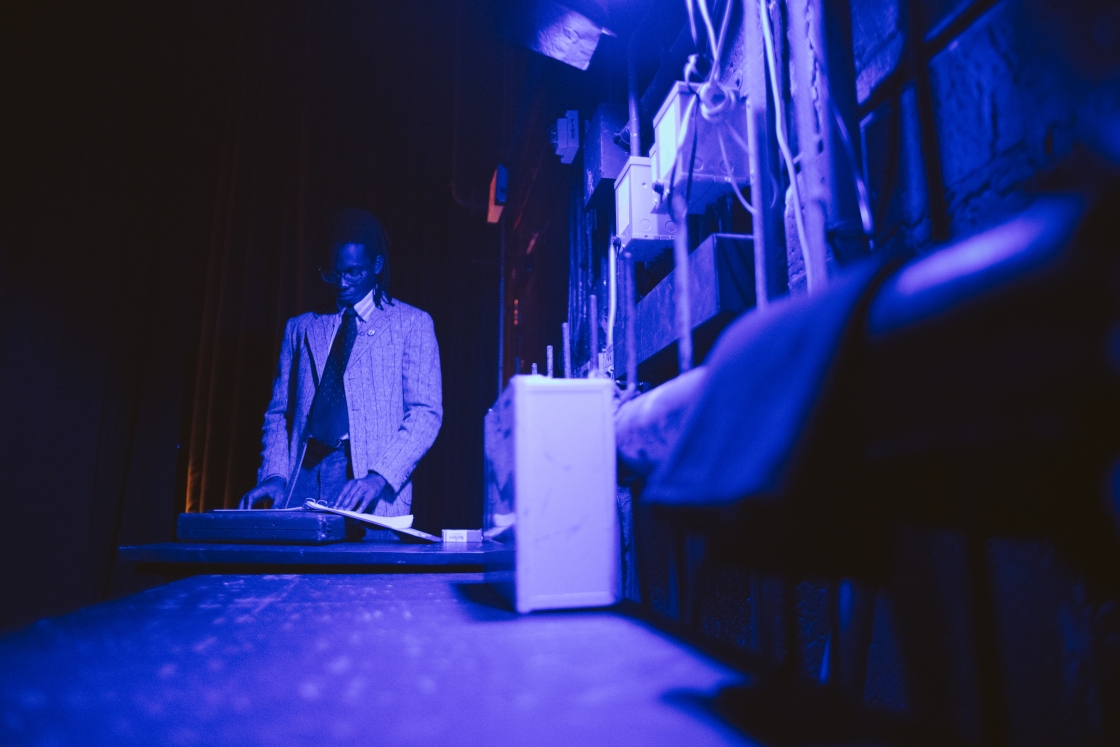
[241,209,442,516]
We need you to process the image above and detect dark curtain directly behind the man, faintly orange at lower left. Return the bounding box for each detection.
[186,0,497,529]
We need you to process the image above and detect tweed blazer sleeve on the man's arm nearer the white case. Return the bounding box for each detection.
[371,312,444,493]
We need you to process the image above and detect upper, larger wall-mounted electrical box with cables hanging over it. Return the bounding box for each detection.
[650,82,750,214]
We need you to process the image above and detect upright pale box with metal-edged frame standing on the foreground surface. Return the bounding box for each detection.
[483,375,622,613]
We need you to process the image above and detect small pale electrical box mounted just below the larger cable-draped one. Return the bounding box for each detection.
[615,156,678,262]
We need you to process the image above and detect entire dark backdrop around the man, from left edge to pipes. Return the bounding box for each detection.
[0,0,500,629]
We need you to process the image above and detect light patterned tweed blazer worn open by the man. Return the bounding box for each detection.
[258,301,444,516]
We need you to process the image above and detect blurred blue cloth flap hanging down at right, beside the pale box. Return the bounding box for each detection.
[642,256,887,505]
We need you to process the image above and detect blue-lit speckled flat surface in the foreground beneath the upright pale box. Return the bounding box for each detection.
[0,573,750,747]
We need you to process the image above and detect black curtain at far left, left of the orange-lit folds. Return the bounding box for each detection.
[0,2,228,629]
